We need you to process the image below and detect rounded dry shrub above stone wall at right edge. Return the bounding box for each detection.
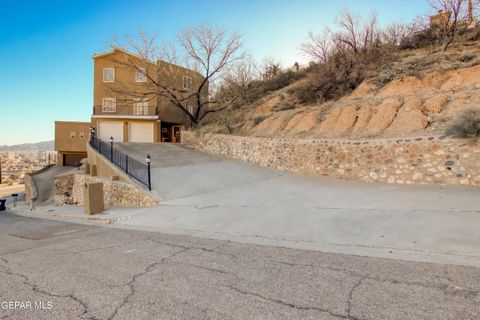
[445,108,480,138]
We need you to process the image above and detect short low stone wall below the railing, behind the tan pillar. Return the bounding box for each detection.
[54,171,158,207]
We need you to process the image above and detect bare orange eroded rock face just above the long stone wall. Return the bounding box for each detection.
[240,65,480,138]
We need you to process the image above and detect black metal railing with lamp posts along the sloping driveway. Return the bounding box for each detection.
[90,135,152,190]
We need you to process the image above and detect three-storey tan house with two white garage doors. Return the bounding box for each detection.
[91,49,203,142]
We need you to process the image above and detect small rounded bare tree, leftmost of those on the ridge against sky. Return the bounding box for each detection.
[300,28,333,63]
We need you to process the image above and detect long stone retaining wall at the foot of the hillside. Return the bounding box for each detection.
[181,131,480,186]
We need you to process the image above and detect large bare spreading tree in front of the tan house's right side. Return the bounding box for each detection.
[111,24,244,127]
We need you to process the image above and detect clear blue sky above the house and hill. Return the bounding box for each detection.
[0,0,429,145]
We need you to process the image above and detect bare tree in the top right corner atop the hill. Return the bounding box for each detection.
[429,0,480,51]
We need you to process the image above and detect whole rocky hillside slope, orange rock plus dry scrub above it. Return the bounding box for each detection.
[201,42,480,138]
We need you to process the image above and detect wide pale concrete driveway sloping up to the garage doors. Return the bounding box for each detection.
[96,143,480,266]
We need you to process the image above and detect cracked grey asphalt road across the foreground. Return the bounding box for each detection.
[0,213,480,320]
